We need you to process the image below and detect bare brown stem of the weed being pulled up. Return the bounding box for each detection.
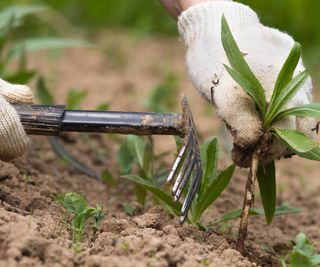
[237,152,260,251]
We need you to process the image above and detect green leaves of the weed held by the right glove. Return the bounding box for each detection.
[221,16,320,224]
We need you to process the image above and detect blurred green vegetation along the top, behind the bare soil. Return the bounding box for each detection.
[0,0,320,77]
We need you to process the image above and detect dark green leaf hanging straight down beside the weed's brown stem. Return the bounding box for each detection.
[257,161,277,225]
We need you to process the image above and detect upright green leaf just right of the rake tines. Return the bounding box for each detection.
[200,138,219,195]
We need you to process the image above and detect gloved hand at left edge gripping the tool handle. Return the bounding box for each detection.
[0,79,33,160]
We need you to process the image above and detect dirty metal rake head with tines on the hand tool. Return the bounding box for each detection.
[167,97,202,224]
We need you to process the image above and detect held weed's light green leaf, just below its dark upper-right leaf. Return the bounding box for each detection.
[265,71,309,126]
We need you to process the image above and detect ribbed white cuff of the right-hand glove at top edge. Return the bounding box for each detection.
[178,1,259,47]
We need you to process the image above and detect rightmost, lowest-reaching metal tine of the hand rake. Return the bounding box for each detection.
[180,162,202,224]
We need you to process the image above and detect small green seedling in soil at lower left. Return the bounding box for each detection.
[55,193,105,252]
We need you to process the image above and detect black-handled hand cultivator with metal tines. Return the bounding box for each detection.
[15,97,202,223]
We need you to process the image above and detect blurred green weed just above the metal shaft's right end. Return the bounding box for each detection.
[143,72,179,112]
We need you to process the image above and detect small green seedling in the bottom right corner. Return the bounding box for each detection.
[281,233,320,267]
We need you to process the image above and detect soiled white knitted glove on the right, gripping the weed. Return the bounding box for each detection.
[178,1,314,166]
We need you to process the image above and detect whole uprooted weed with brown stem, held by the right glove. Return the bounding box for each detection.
[221,16,320,250]
